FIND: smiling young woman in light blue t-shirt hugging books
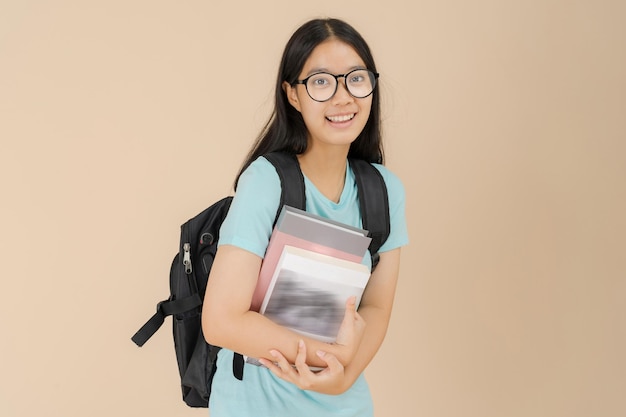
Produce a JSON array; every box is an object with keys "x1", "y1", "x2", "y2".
[{"x1": 203, "y1": 19, "x2": 408, "y2": 417}]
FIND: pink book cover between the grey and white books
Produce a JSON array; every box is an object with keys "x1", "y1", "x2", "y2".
[{"x1": 250, "y1": 228, "x2": 365, "y2": 311}]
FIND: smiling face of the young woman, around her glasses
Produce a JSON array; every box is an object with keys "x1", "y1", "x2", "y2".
[{"x1": 283, "y1": 39, "x2": 372, "y2": 152}]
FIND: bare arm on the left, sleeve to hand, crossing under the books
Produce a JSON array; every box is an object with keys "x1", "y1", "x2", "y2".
[{"x1": 202, "y1": 245, "x2": 364, "y2": 366}]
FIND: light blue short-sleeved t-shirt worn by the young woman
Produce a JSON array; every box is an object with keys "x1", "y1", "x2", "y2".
[{"x1": 209, "y1": 158, "x2": 408, "y2": 417}]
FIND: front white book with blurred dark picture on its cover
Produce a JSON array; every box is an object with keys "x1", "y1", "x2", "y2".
[{"x1": 259, "y1": 245, "x2": 370, "y2": 343}]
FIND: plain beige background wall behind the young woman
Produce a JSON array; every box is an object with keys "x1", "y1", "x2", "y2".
[{"x1": 0, "y1": 0, "x2": 626, "y2": 417}]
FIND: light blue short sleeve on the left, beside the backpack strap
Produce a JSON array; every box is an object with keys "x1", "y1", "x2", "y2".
[{"x1": 219, "y1": 157, "x2": 281, "y2": 258}]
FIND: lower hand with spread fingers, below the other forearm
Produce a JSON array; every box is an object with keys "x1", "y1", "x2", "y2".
[{"x1": 259, "y1": 340, "x2": 352, "y2": 395}]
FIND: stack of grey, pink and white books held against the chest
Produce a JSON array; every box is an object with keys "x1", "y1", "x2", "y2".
[{"x1": 251, "y1": 206, "x2": 371, "y2": 342}]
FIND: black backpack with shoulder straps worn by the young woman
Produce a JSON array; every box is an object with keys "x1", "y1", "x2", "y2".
[{"x1": 131, "y1": 152, "x2": 390, "y2": 407}]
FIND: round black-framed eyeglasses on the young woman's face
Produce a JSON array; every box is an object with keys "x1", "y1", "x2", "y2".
[{"x1": 295, "y1": 69, "x2": 379, "y2": 102}]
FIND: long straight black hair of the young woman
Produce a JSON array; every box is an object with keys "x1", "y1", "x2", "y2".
[{"x1": 235, "y1": 19, "x2": 384, "y2": 188}]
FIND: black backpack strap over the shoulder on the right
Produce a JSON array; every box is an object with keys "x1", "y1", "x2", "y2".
[{"x1": 350, "y1": 159, "x2": 391, "y2": 271}]
